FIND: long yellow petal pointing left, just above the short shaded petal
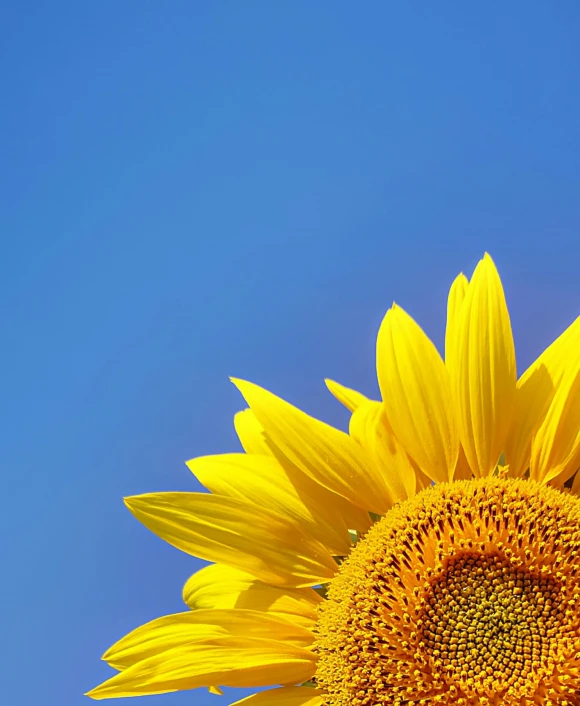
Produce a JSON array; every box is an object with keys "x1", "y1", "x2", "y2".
[{"x1": 125, "y1": 493, "x2": 336, "y2": 587}]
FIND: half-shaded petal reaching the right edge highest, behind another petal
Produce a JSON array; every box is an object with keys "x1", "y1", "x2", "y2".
[{"x1": 505, "y1": 317, "x2": 580, "y2": 477}]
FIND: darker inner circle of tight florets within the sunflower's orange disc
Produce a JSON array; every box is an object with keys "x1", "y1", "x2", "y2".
[{"x1": 418, "y1": 553, "x2": 565, "y2": 691}]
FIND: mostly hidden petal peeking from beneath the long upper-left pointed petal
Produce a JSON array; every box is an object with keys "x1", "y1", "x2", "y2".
[{"x1": 234, "y1": 409, "x2": 372, "y2": 532}]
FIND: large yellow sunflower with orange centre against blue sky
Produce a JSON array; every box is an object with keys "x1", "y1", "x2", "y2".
[{"x1": 89, "y1": 255, "x2": 580, "y2": 706}]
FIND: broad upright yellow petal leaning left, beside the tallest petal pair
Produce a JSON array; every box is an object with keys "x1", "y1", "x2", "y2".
[{"x1": 377, "y1": 305, "x2": 459, "y2": 481}]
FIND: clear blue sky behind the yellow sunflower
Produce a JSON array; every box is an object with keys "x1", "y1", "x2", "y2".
[{"x1": 0, "y1": 0, "x2": 580, "y2": 706}]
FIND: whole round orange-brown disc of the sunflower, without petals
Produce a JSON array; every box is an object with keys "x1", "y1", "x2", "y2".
[{"x1": 316, "y1": 478, "x2": 580, "y2": 706}]
